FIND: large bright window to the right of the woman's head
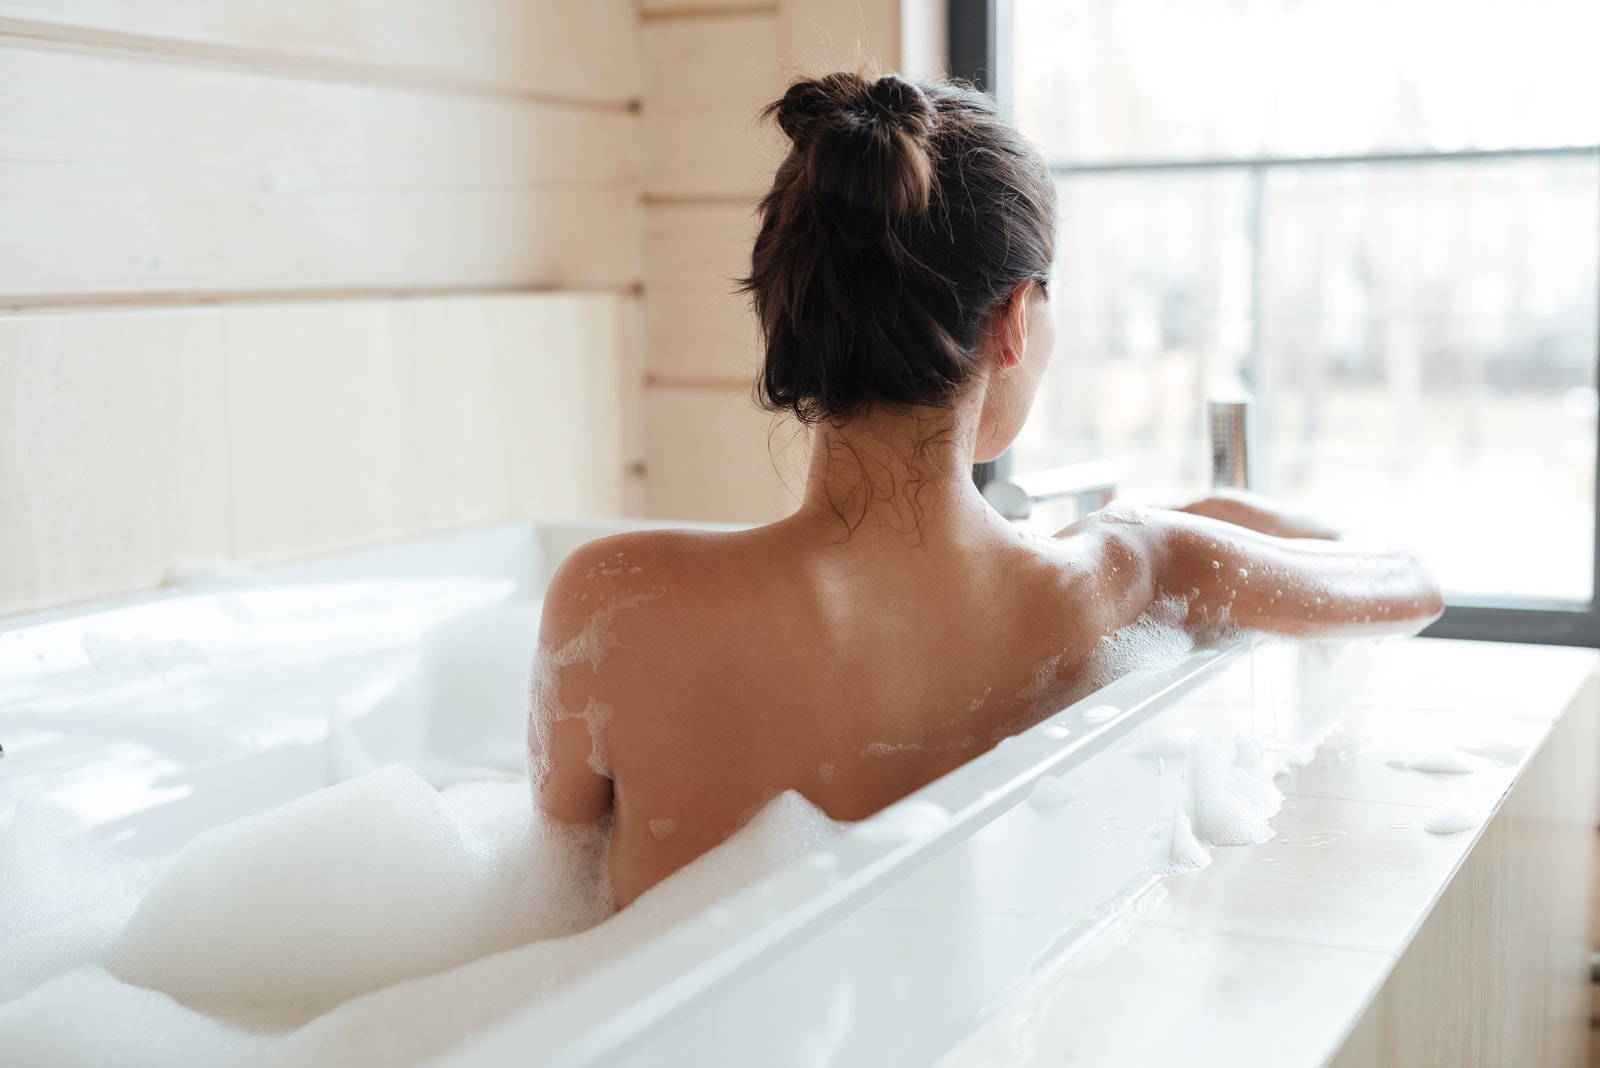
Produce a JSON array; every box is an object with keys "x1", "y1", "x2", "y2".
[{"x1": 972, "y1": 0, "x2": 1600, "y2": 644}]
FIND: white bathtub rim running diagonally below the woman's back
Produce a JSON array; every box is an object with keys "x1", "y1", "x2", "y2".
[{"x1": 427, "y1": 640, "x2": 1273, "y2": 1068}]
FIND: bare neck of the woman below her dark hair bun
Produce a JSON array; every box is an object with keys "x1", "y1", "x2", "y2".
[{"x1": 795, "y1": 409, "x2": 989, "y2": 545}]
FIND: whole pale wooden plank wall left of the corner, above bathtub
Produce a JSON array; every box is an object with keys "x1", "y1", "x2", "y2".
[{"x1": 0, "y1": 0, "x2": 645, "y2": 614}]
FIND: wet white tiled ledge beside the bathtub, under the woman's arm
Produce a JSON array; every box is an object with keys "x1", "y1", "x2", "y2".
[{"x1": 949, "y1": 640, "x2": 1597, "y2": 1066}]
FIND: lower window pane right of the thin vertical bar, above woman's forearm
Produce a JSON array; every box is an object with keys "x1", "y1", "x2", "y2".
[{"x1": 1245, "y1": 158, "x2": 1600, "y2": 601}]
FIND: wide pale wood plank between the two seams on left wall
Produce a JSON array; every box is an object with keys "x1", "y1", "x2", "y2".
[{"x1": 0, "y1": 41, "x2": 642, "y2": 305}]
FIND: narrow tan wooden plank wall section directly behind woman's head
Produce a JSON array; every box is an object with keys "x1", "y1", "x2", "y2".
[{"x1": 640, "y1": 0, "x2": 901, "y2": 521}]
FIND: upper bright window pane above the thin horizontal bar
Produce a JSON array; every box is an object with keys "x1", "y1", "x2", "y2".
[{"x1": 1013, "y1": 0, "x2": 1600, "y2": 163}]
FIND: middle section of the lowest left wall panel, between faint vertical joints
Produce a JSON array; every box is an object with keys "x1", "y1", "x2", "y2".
[{"x1": 221, "y1": 302, "x2": 451, "y2": 561}]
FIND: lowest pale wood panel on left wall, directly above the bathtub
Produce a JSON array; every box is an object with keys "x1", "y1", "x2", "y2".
[{"x1": 0, "y1": 294, "x2": 635, "y2": 614}]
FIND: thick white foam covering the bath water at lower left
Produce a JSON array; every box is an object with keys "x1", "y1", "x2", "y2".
[{"x1": 0, "y1": 767, "x2": 844, "y2": 1068}]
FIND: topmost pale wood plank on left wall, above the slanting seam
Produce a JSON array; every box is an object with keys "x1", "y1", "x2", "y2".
[{"x1": 0, "y1": 0, "x2": 638, "y2": 106}]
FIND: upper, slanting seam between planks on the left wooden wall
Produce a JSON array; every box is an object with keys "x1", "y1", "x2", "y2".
[{"x1": 0, "y1": 18, "x2": 642, "y2": 112}]
